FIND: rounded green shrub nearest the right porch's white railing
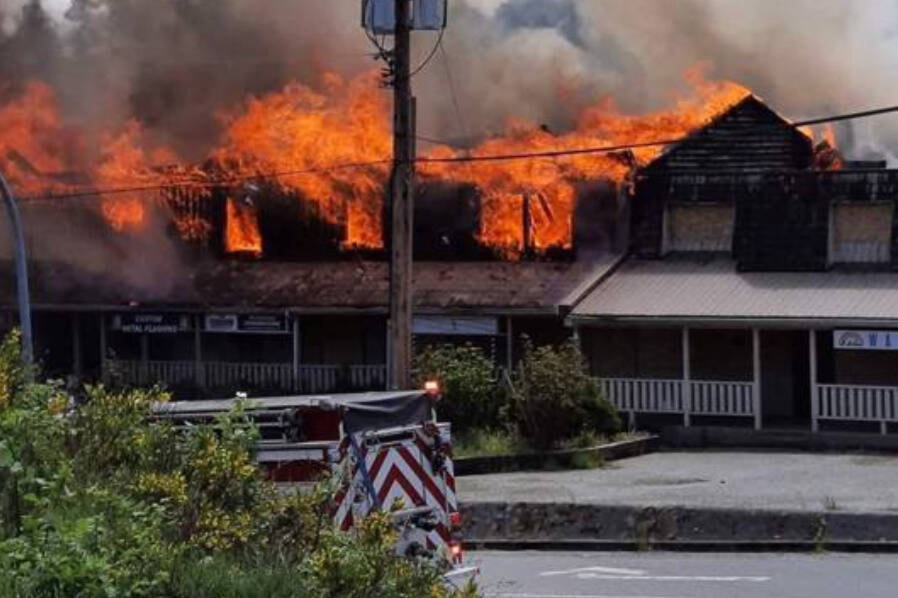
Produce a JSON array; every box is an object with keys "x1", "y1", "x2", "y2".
[{"x1": 510, "y1": 342, "x2": 620, "y2": 450}]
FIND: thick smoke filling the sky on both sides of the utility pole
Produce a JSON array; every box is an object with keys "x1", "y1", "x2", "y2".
[{"x1": 0, "y1": 0, "x2": 898, "y2": 296}]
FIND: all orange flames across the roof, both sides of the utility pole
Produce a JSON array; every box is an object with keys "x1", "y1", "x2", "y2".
[{"x1": 0, "y1": 69, "x2": 768, "y2": 257}]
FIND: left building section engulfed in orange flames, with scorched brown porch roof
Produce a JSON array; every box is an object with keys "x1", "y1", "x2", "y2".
[{"x1": 0, "y1": 61, "x2": 764, "y2": 395}]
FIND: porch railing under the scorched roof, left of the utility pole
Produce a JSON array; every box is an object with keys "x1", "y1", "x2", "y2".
[{"x1": 104, "y1": 359, "x2": 387, "y2": 393}]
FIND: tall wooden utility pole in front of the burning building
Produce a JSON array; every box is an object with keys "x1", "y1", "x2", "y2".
[{"x1": 387, "y1": 0, "x2": 415, "y2": 389}]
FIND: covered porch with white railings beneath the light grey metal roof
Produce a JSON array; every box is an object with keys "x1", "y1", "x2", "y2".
[{"x1": 581, "y1": 327, "x2": 898, "y2": 434}]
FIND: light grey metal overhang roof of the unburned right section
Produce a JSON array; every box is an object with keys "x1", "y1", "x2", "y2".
[{"x1": 570, "y1": 255, "x2": 898, "y2": 324}]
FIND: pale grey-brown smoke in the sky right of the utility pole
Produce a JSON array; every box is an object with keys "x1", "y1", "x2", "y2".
[{"x1": 416, "y1": 0, "x2": 898, "y2": 159}]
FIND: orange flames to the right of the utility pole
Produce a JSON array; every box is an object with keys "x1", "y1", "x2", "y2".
[{"x1": 422, "y1": 70, "x2": 750, "y2": 257}]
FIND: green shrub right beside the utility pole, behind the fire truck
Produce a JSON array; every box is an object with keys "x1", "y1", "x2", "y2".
[{"x1": 415, "y1": 345, "x2": 502, "y2": 431}]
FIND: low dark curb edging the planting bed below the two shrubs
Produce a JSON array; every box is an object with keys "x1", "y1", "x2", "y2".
[{"x1": 453, "y1": 436, "x2": 661, "y2": 477}]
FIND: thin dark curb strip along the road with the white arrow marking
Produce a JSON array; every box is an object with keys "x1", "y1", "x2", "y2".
[{"x1": 465, "y1": 540, "x2": 898, "y2": 554}]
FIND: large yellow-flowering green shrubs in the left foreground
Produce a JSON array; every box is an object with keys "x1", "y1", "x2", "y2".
[{"x1": 0, "y1": 332, "x2": 473, "y2": 598}]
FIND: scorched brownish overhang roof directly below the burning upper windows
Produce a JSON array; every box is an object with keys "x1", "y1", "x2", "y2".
[{"x1": 0, "y1": 256, "x2": 617, "y2": 313}]
